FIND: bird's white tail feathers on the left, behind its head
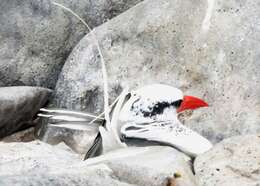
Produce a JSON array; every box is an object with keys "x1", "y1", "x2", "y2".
[{"x1": 38, "y1": 89, "x2": 129, "y2": 159}]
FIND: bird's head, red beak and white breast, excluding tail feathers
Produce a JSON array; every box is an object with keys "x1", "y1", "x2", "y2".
[{"x1": 118, "y1": 84, "x2": 212, "y2": 157}]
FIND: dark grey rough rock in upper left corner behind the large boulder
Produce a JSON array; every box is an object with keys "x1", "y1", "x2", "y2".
[{"x1": 0, "y1": 0, "x2": 141, "y2": 88}]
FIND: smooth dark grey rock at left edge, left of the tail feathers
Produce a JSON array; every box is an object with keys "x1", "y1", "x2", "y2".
[{"x1": 0, "y1": 86, "x2": 52, "y2": 138}]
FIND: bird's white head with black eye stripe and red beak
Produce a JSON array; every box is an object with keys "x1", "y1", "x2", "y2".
[{"x1": 120, "y1": 84, "x2": 208, "y2": 122}]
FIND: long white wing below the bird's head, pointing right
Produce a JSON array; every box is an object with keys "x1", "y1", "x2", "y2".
[{"x1": 121, "y1": 121, "x2": 212, "y2": 157}]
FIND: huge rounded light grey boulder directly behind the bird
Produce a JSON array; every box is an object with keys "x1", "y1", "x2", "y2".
[{"x1": 52, "y1": 0, "x2": 260, "y2": 142}]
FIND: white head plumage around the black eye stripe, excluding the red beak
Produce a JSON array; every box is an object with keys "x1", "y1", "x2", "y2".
[{"x1": 119, "y1": 84, "x2": 183, "y2": 123}]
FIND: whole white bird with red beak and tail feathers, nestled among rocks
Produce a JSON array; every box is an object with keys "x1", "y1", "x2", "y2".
[{"x1": 38, "y1": 84, "x2": 212, "y2": 159}]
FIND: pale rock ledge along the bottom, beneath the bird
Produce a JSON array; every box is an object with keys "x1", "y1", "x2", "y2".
[{"x1": 0, "y1": 141, "x2": 195, "y2": 186}]
